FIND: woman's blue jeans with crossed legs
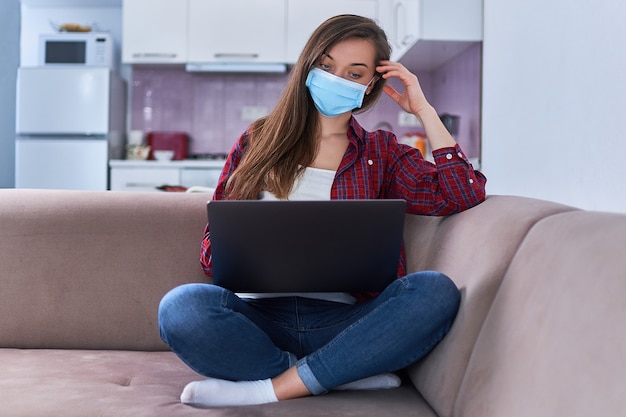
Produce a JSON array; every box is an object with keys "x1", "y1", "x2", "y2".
[{"x1": 159, "y1": 271, "x2": 460, "y2": 395}]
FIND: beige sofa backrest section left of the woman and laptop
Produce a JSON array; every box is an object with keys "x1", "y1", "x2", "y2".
[{"x1": 0, "y1": 189, "x2": 210, "y2": 350}]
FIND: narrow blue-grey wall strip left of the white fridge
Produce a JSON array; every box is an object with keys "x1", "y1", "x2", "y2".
[{"x1": 0, "y1": 0, "x2": 20, "y2": 188}]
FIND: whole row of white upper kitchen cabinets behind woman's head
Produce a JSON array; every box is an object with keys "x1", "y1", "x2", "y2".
[{"x1": 122, "y1": 0, "x2": 483, "y2": 71}]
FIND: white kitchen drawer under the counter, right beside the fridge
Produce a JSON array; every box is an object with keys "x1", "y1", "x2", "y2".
[{"x1": 111, "y1": 167, "x2": 181, "y2": 191}]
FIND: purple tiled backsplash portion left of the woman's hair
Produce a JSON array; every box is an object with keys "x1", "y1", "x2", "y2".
[{"x1": 130, "y1": 66, "x2": 287, "y2": 154}]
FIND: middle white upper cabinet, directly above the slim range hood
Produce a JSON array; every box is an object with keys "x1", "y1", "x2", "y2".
[{"x1": 188, "y1": 0, "x2": 286, "y2": 64}]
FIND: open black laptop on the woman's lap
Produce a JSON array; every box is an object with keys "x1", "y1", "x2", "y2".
[{"x1": 207, "y1": 200, "x2": 406, "y2": 293}]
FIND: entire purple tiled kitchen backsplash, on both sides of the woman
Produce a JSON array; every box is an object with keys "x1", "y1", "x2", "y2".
[{"x1": 131, "y1": 45, "x2": 481, "y2": 158}]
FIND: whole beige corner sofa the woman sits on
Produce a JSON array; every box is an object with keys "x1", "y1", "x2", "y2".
[{"x1": 0, "y1": 189, "x2": 626, "y2": 417}]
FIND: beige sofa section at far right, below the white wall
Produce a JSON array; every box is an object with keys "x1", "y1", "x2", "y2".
[{"x1": 455, "y1": 211, "x2": 626, "y2": 417}]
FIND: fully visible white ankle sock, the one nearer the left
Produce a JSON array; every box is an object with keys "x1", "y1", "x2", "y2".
[{"x1": 180, "y1": 378, "x2": 278, "y2": 407}]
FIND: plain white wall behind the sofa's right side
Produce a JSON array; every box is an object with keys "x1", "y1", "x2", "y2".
[{"x1": 482, "y1": 0, "x2": 626, "y2": 212}]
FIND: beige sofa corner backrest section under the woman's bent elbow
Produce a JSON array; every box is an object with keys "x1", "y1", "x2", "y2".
[{"x1": 405, "y1": 196, "x2": 575, "y2": 416}]
